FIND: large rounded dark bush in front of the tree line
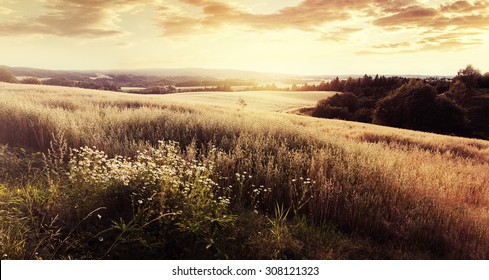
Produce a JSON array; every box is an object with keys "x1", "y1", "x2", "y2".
[{"x1": 373, "y1": 80, "x2": 469, "y2": 135}]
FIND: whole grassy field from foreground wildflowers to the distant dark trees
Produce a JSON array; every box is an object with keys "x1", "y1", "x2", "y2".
[{"x1": 0, "y1": 83, "x2": 489, "y2": 259}]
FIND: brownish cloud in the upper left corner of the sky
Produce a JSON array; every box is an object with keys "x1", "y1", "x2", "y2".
[{"x1": 0, "y1": 0, "x2": 148, "y2": 38}]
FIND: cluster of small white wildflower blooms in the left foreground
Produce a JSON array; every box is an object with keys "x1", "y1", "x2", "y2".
[{"x1": 69, "y1": 141, "x2": 234, "y2": 242}]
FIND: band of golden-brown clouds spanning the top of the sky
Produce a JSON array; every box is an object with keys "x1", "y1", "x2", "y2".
[{"x1": 0, "y1": 0, "x2": 489, "y2": 55}]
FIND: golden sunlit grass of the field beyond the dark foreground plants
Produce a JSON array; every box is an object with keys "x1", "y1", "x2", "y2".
[{"x1": 0, "y1": 83, "x2": 489, "y2": 258}]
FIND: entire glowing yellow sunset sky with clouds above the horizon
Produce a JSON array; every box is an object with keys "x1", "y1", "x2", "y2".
[{"x1": 0, "y1": 0, "x2": 489, "y2": 75}]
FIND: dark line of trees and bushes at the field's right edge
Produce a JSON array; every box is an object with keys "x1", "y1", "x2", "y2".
[{"x1": 310, "y1": 65, "x2": 489, "y2": 138}]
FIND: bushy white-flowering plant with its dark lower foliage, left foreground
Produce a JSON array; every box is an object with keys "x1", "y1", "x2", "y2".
[{"x1": 44, "y1": 141, "x2": 235, "y2": 259}]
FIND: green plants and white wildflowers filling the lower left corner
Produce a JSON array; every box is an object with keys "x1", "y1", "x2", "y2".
[{"x1": 0, "y1": 138, "x2": 235, "y2": 259}]
